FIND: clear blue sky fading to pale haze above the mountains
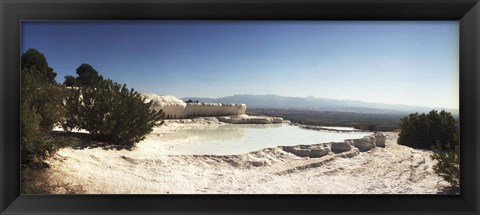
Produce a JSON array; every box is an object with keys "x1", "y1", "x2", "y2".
[{"x1": 21, "y1": 21, "x2": 459, "y2": 109}]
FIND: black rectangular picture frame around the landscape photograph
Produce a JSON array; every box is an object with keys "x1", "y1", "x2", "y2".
[{"x1": 0, "y1": 0, "x2": 480, "y2": 214}]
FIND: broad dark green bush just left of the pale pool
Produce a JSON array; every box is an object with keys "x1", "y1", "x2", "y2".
[{"x1": 63, "y1": 80, "x2": 164, "y2": 147}]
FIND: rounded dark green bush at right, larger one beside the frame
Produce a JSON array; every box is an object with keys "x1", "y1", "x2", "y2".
[{"x1": 397, "y1": 110, "x2": 458, "y2": 150}]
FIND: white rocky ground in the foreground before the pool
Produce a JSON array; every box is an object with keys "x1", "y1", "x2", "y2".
[{"x1": 43, "y1": 120, "x2": 448, "y2": 194}]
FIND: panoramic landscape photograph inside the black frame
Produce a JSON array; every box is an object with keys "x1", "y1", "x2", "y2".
[{"x1": 19, "y1": 20, "x2": 463, "y2": 196}]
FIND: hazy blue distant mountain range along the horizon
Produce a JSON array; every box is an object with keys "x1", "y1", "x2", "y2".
[{"x1": 182, "y1": 95, "x2": 458, "y2": 115}]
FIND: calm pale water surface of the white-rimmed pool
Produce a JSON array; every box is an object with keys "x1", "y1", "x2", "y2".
[{"x1": 153, "y1": 124, "x2": 371, "y2": 155}]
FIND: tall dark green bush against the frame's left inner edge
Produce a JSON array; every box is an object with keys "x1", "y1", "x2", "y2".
[{"x1": 20, "y1": 49, "x2": 63, "y2": 165}]
